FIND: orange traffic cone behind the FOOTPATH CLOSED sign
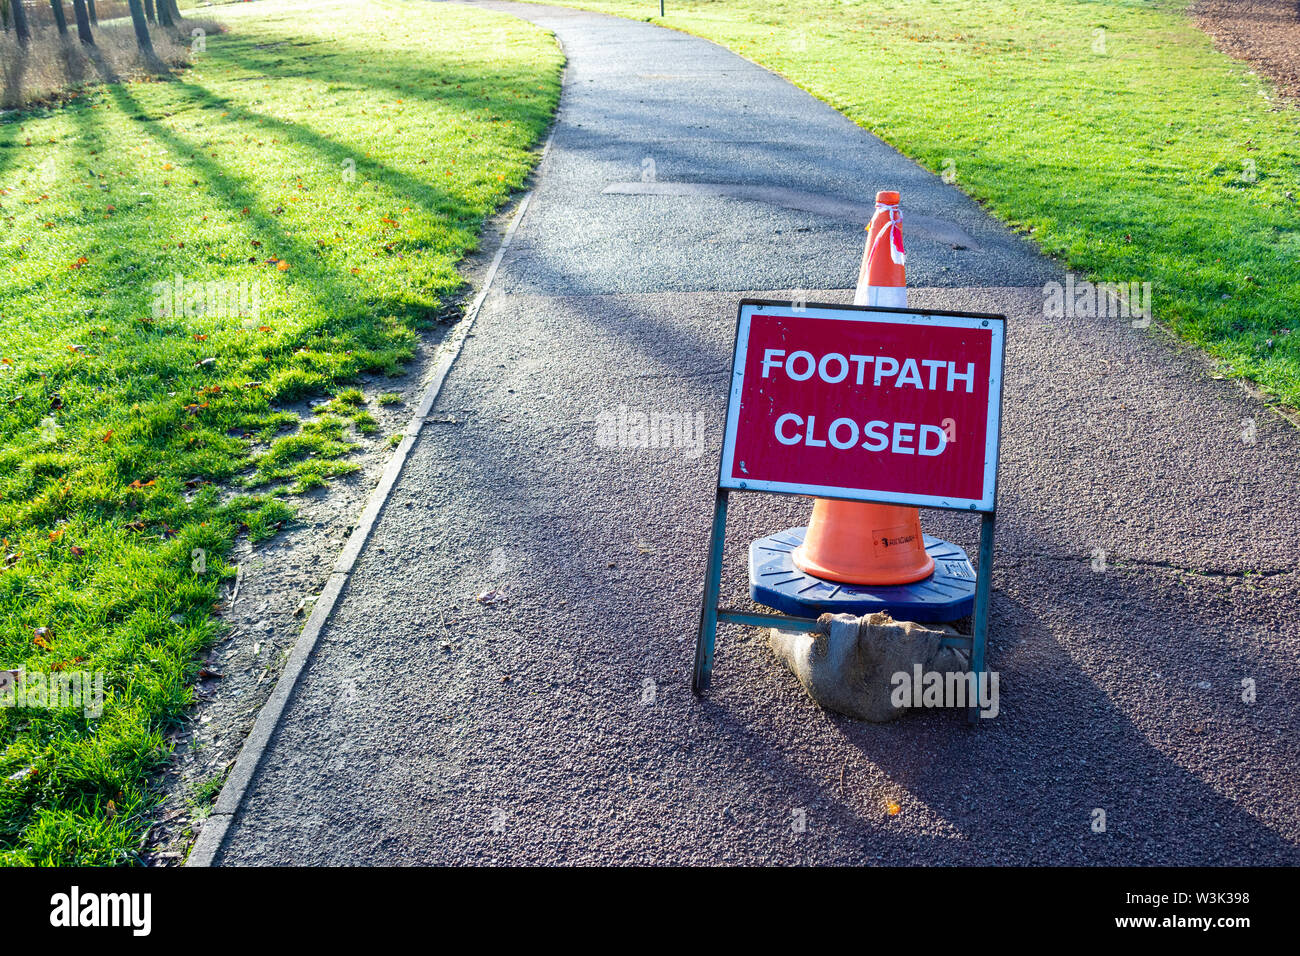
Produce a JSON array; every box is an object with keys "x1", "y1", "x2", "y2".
[{"x1": 792, "y1": 190, "x2": 935, "y2": 587}]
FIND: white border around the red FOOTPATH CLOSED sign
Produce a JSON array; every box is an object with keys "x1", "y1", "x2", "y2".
[{"x1": 718, "y1": 302, "x2": 1006, "y2": 511}]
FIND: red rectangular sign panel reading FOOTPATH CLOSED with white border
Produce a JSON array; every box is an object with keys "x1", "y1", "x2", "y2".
[{"x1": 719, "y1": 299, "x2": 1004, "y2": 511}]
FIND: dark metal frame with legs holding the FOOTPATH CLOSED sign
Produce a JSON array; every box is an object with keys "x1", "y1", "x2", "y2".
[{"x1": 690, "y1": 299, "x2": 1006, "y2": 723}]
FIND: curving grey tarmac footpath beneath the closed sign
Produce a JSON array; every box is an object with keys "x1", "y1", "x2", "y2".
[{"x1": 208, "y1": 3, "x2": 1300, "y2": 865}]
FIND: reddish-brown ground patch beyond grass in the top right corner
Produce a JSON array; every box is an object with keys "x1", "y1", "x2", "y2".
[{"x1": 1192, "y1": 0, "x2": 1300, "y2": 100}]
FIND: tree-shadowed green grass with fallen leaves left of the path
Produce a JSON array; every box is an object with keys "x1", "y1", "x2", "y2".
[{"x1": 0, "y1": 0, "x2": 562, "y2": 864}]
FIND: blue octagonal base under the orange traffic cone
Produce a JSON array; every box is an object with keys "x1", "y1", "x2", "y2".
[{"x1": 749, "y1": 528, "x2": 975, "y2": 623}]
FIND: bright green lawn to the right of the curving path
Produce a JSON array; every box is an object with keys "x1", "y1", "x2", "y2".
[{"x1": 538, "y1": 0, "x2": 1300, "y2": 406}]
